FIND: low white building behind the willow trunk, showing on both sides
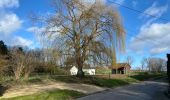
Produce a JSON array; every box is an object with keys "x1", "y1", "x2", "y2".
[{"x1": 70, "y1": 66, "x2": 95, "y2": 75}]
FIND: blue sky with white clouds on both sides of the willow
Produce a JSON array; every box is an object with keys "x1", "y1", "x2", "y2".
[{"x1": 0, "y1": 0, "x2": 170, "y2": 68}]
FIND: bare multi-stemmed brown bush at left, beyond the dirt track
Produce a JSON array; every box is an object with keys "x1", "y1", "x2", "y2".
[{"x1": 10, "y1": 48, "x2": 38, "y2": 80}]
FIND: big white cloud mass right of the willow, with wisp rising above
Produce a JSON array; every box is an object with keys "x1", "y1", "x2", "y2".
[{"x1": 129, "y1": 2, "x2": 170, "y2": 55}]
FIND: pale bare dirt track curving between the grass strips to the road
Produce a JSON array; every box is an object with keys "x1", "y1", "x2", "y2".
[{"x1": 0, "y1": 82, "x2": 105, "y2": 98}]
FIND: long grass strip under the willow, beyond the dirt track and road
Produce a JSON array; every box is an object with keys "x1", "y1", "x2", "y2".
[{"x1": 0, "y1": 73, "x2": 165, "y2": 87}]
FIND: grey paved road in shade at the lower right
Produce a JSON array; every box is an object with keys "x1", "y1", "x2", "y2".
[{"x1": 78, "y1": 80, "x2": 170, "y2": 100}]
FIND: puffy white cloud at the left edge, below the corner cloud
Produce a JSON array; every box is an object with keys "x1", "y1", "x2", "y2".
[{"x1": 0, "y1": 13, "x2": 22, "y2": 35}]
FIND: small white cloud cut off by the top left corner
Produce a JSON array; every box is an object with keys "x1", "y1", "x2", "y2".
[{"x1": 0, "y1": 0, "x2": 19, "y2": 8}]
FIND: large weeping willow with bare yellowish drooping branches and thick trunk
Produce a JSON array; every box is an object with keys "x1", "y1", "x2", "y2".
[{"x1": 33, "y1": 0, "x2": 125, "y2": 77}]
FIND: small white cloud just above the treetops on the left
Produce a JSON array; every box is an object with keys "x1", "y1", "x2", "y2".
[{"x1": 13, "y1": 36, "x2": 33, "y2": 47}]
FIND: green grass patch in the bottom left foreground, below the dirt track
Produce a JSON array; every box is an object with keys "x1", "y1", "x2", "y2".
[{"x1": 1, "y1": 90, "x2": 84, "y2": 100}]
